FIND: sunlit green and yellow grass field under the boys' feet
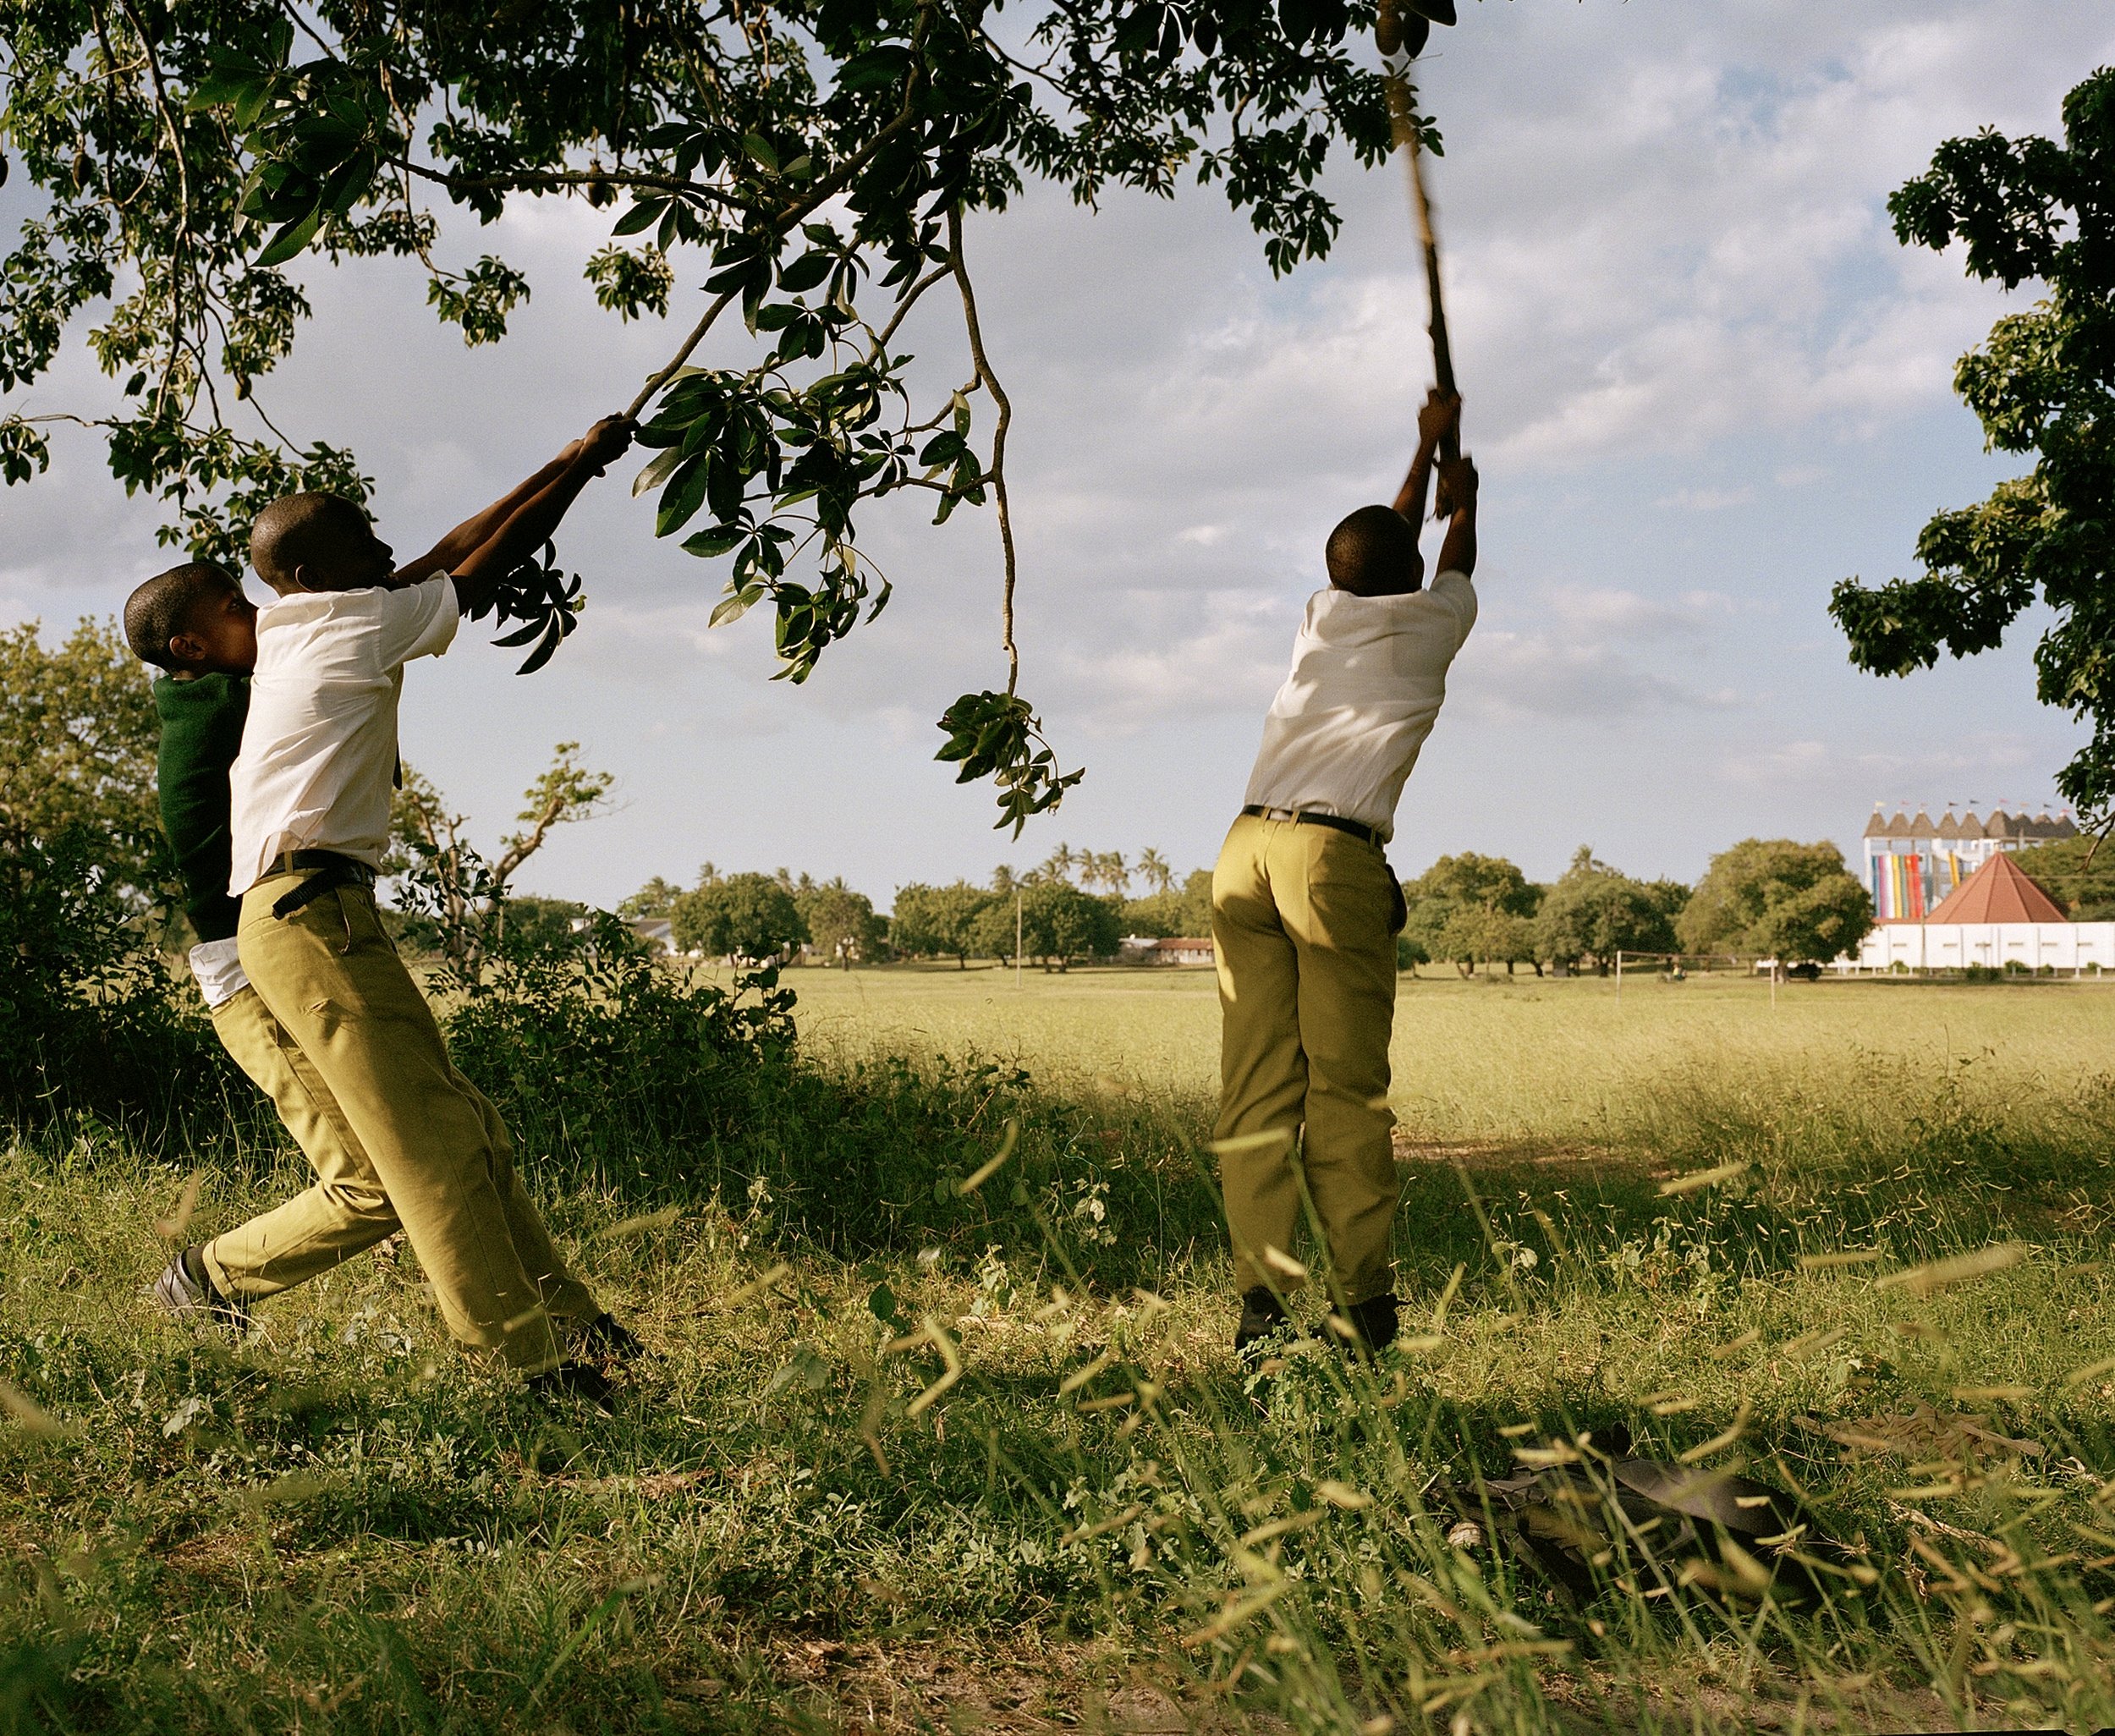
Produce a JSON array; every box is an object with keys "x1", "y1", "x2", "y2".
[{"x1": 0, "y1": 969, "x2": 2115, "y2": 1736}]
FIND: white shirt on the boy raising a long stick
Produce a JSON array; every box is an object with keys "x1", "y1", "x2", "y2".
[{"x1": 1244, "y1": 571, "x2": 1476, "y2": 838}]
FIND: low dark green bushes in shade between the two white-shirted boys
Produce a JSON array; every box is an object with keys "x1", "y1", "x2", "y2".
[{"x1": 447, "y1": 915, "x2": 1218, "y2": 1283}]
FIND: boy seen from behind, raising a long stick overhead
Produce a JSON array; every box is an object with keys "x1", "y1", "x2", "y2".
[{"x1": 1212, "y1": 391, "x2": 1476, "y2": 1354}]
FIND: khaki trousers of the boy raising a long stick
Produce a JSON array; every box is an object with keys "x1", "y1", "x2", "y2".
[{"x1": 1212, "y1": 814, "x2": 1398, "y2": 1305}]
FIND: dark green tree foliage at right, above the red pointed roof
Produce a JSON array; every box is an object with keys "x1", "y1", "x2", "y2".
[{"x1": 1830, "y1": 68, "x2": 2115, "y2": 818}]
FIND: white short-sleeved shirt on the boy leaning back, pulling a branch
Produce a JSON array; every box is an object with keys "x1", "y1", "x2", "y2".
[{"x1": 228, "y1": 575, "x2": 461, "y2": 898}]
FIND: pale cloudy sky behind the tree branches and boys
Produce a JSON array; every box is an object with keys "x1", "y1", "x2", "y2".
[{"x1": 0, "y1": 0, "x2": 2115, "y2": 907}]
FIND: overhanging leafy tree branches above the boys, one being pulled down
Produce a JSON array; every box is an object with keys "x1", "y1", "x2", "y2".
[{"x1": 0, "y1": 0, "x2": 1421, "y2": 829}]
